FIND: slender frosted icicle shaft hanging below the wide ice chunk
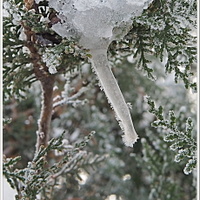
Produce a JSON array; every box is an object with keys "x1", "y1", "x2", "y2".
[{"x1": 91, "y1": 49, "x2": 138, "y2": 147}]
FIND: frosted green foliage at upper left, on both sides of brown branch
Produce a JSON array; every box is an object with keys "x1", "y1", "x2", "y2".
[{"x1": 3, "y1": 0, "x2": 87, "y2": 100}]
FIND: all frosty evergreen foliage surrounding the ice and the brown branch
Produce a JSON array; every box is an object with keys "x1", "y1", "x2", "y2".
[{"x1": 3, "y1": 0, "x2": 197, "y2": 200}]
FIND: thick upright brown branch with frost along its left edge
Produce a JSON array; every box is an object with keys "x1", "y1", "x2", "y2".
[{"x1": 22, "y1": 23, "x2": 55, "y2": 151}]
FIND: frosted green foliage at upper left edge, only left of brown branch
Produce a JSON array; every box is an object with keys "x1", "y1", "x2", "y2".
[{"x1": 3, "y1": 1, "x2": 34, "y2": 98}]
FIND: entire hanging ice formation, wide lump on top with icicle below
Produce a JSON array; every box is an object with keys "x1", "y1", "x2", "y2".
[{"x1": 49, "y1": 0, "x2": 153, "y2": 147}]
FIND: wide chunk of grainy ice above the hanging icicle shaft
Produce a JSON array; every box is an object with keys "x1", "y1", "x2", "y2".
[{"x1": 49, "y1": 0, "x2": 152, "y2": 49}]
